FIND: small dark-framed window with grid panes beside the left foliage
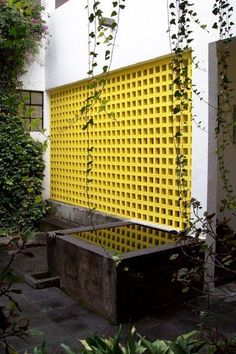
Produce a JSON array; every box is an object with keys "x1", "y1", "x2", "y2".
[{"x1": 21, "y1": 90, "x2": 43, "y2": 131}]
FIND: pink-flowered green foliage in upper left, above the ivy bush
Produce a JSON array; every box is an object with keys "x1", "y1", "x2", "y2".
[{"x1": 0, "y1": 0, "x2": 47, "y2": 112}]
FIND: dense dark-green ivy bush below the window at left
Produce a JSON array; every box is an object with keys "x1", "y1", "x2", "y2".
[{"x1": 0, "y1": 113, "x2": 45, "y2": 233}]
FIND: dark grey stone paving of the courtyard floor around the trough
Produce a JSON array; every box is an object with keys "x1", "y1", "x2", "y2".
[{"x1": 0, "y1": 239, "x2": 236, "y2": 354}]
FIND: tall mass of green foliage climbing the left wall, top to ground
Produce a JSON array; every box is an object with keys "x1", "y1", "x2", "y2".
[{"x1": 0, "y1": 0, "x2": 47, "y2": 235}]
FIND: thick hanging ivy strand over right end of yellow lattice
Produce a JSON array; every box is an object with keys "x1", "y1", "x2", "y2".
[{"x1": 168, "y1": 0, "x2": 195, "y2": 227}]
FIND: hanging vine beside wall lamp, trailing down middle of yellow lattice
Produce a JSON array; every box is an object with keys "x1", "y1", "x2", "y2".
[{"x1": 80, "y1": 0, "x2": 125, "y2": 232}]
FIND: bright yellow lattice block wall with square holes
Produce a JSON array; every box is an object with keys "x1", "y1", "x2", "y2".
[{"x1": 50, "y1": 57, "x2": 192, "y2": 228}]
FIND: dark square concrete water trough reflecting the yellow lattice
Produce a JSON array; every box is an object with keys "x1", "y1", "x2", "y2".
[{"x1": 47, "y1": 221, "x2": 204, "y2": 324}]
